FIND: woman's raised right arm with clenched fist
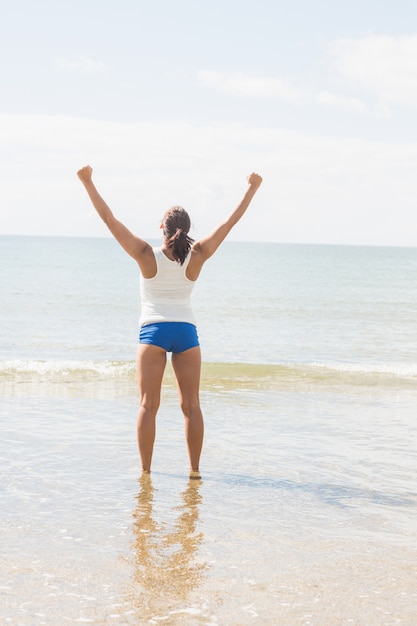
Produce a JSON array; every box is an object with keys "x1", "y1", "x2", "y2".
[{"x1": 193, "y1": 172, "x2": 262, "y2": 262}]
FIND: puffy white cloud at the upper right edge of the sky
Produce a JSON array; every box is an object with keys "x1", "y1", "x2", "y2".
[{"x1": 328, "y1": 34, "x2": 417, "y2": 108}]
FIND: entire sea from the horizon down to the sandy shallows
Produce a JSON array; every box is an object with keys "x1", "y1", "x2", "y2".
[{"x1": 0, "y1": 236, "x2": 417, "y2": 626}]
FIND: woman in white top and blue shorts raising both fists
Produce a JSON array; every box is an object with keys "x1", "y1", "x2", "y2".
[{"x1": 78, "y1": 165, "x2": 262, "y2": 478}]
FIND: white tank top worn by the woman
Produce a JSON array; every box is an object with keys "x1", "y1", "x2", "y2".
[{"x1": 139, "y1": 248, "x2": 196, "y2": 326}]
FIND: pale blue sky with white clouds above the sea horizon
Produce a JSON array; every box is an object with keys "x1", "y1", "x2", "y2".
[{"x1": 0, "y1": 0, "x2": 417, "y2": 246}]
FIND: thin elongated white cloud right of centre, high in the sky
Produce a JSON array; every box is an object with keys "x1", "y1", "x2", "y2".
[{"x1": 199, "y1": 70, "x2": 301, "y2": 101}]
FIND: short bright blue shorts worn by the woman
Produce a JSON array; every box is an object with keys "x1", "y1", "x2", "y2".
[{"x1": 139, "y1": 322, "x2": 200, "y2": 354}]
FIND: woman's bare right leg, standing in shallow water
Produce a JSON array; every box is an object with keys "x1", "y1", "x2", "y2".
[{"x1": 172, "y1": 346, "x2": 204, "y2": 472}]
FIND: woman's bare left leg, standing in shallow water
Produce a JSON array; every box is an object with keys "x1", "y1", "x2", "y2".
[{"x1": 136, "y1": 343, "x2": 167, "y2": 472}]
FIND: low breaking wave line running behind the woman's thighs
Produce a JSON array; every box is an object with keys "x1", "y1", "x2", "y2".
[{"x1": 0, "y1": 360, "x2": 417, "y2": 390}]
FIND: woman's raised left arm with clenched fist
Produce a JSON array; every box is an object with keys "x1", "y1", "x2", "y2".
[{"x1": 77, "y1": 165, "x2": 151, "y2": 267}]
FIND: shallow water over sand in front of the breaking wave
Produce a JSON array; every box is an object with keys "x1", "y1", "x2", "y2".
[{"x1": 0, "y1": 376, "x2": 417, "y2": 626}]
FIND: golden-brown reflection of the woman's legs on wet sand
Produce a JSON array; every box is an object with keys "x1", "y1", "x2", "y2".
[{"x1": 127, "y1": 474, "x2": 206, "y2": 619}]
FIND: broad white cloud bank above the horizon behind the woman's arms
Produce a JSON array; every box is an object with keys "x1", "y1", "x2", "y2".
[{"x1": 0, "y1": 115, "x2": 417, "y2": 246}]
